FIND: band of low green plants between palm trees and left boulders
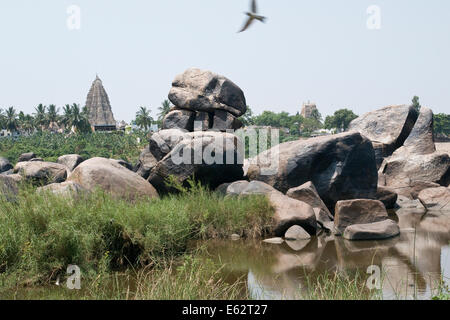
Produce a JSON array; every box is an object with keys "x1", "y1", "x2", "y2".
[{"x1": 0, "y1": 131, "x2": 147, "y2": 163}]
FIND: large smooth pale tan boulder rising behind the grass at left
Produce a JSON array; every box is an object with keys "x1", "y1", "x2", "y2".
[{"x1": 67, "y1": 158, "x2": 158, "y2": 200}]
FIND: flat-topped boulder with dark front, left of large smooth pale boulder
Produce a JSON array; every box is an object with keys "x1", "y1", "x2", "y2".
[{"x1": 14, "y1": 161, "x2": 67, "y2": 185}]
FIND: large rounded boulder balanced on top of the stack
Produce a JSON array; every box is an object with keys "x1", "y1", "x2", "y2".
[{"x1": 169, "y1": 68, "x2": 247, "y2": 117}]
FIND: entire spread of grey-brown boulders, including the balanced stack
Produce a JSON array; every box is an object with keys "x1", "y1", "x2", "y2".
[{"x1": 0, "y1": 69, "x2": 450, "y2": 247}]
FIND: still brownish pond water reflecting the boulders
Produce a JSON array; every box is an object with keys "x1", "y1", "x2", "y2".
[{"x1": 200, "y1": 210, "x2": 450, "y2": 299}]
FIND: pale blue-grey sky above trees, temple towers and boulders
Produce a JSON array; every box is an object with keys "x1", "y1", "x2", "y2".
[{"x1": 0, "y1": 0, "x2": 450, "y2": 121}]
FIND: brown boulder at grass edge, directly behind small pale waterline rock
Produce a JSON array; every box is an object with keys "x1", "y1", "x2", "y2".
[{"x1": 268, "y1": 192, "x2": 317, "y2": 237}]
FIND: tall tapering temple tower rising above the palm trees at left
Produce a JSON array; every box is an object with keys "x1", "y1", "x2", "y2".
[{"x1": 86, "y1": 75, "x2": 116, "y2": 131}]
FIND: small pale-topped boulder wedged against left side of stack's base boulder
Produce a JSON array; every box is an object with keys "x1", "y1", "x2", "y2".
[{"x1": 149, "y1": 129, "x2": 188, "y2": 161}]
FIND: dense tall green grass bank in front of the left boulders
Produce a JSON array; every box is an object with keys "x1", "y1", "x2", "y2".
[{"x1": 0, "y1": 181, "x2": 273, "y2": 287}]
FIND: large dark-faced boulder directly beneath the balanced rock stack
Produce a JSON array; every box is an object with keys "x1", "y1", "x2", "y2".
[{"x1": 149, "y1": 131, "x2": 243, "y2": 192}]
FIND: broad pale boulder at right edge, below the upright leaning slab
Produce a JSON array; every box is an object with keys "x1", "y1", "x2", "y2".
[{"x1": 379, "y1": 152, "x2": 450, "y2": 199}]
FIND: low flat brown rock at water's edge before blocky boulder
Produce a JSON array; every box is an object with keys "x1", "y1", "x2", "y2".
[{"x1": 343, "y1": 219, "x2": 400, "y2": 240}]
